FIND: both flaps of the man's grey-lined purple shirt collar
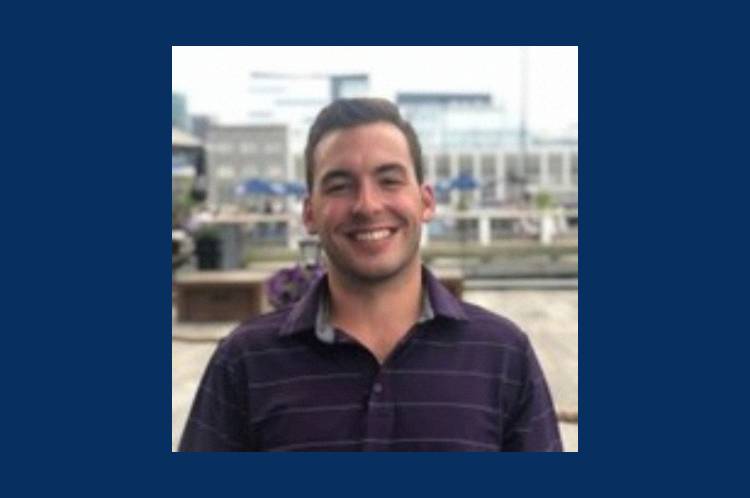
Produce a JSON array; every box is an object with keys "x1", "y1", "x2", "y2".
[{"x1": 279, "y1": 267, "x2": 467, "y2": 342}]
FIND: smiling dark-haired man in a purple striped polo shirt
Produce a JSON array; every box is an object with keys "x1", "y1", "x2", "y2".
[{"x1": 180, "y1": 99, "x2": 561, "y2": 451}]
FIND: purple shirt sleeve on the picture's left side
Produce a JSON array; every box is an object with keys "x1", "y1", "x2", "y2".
[{"x1": 178, "y1": 339, "x2": 253, "y2": 451}]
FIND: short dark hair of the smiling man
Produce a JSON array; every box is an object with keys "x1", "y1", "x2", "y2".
[{"x1": 305, "y1": 98, "x2": 424, "y2": 193}]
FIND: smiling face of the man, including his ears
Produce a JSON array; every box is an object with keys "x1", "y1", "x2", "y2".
[{"x1": 304, "y1": 122, "x2": 435, "y2": 282}]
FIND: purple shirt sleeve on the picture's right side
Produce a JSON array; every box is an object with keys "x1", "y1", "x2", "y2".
[{"x1": 503, "y1": 338, "x2": 563, "y2": 451}]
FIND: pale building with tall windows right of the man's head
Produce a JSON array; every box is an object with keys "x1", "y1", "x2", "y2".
[{"x1": 396, "y1": 93, "x2": 578, "y2": 207}]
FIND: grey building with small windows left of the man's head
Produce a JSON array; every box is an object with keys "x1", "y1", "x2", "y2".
[{"x1": 206, "y1": 125, "x2": 293, "y2": 205}]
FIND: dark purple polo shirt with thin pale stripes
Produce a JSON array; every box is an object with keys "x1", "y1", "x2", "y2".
[{"x1": 179, "y1": 269, "x2": 562, "y2": 451}]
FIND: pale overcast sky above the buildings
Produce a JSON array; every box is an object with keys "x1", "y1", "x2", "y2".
[{"x1": 172, "y1": 46, "x2": 578, "y2": 134}]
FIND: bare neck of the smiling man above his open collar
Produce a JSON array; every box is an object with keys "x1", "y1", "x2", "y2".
[{"x1": 328, "y1": 261, "x2": 422, "y2": 363}]
